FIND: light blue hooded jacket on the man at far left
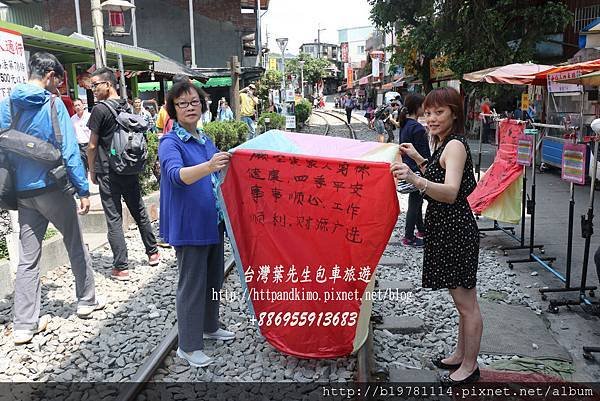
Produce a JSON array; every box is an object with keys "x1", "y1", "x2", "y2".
[{"x1": 0, "y1": 83, "x2": 90, "y2": 196}]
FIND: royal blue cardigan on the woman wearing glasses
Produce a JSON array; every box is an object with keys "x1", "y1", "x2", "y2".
[{"x1": 158, "y1": 123, "x2": 221, "y2": 246}]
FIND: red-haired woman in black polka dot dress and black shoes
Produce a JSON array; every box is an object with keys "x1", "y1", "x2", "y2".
[{"x1": 391, "y1": 88, "x2": 483, "y2": 385}]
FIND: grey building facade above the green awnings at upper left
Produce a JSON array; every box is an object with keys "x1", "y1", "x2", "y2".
[{"x1": 0, "y1": 0, "x2": 269, "y2": 67}]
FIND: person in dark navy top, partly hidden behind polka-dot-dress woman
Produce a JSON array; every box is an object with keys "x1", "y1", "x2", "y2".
[{"x1": 398, "y1": 93, "x2": 431, "y2": 247}]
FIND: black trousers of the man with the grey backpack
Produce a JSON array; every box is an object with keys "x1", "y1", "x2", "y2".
[{"x1": 96, "y1": 173, "x2": 158, "y2": 270}]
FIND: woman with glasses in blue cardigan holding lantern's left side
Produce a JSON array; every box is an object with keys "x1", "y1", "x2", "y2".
[{"x1": 158, "y1": 82, "x2": 235, "y2": 367}]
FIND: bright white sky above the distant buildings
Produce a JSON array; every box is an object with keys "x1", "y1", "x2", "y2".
[{"x1": 261, "y1": 0, "x2": 372, "y2": 54}]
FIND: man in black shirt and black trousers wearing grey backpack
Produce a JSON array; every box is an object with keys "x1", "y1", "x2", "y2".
[{"x1": 88, "y1": 67, "x2": 160, "y2": 280}]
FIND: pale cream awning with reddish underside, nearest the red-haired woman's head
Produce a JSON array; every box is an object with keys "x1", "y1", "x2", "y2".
[{"x1": 463, "y1": 63, "x2": 554, "y2": 85}]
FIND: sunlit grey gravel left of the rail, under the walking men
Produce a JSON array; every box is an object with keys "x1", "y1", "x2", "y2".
[{"x1": 0, "y1": 223, "x2": 223, "y2": 382}]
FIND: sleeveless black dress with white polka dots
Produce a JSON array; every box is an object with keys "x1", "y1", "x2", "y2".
[{"x1": 422, "y1": 135, "x2": 479, "y2": 290}]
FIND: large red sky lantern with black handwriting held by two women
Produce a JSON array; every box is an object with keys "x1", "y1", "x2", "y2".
[{"x1": 220, "y1": 130, "x2": 399, "y2": 358}]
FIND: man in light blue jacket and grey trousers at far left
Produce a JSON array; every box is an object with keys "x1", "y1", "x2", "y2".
[{"x1": 0, "y1": 52, "x2": 104, "y2": 344}]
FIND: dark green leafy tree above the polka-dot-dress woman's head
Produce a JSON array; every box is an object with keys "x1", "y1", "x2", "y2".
[{"x1": 369, "y1": 0, "x2": 572, "y2": 91}]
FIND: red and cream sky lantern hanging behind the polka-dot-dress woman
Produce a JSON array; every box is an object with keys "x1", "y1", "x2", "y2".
[{"x1": 468, "y1": 120, "x2": 524, "y2": 224}]
